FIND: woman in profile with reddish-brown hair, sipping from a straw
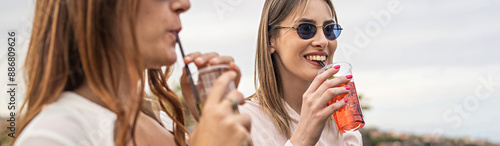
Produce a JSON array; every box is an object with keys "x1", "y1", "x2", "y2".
[{"x1": 14, "y1": 0, "x2": 250, "y2": 146}]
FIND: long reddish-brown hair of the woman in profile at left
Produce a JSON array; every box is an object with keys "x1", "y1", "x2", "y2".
[{"x1": 17, "y1": 0, "x2": 187, "y2": 146}]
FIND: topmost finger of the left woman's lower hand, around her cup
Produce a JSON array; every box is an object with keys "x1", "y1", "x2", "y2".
[{"x1": 205, "y1": 71, "x2": 236, "y2": 106}]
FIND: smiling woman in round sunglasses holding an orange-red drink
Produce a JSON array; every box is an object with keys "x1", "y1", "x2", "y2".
[{"x1": 239, "y1": 0, "x2": 362, "y2": 146}]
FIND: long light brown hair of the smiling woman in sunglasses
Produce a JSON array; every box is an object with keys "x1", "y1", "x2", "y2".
[{"x1": 248, "y1": 0, "x2": 338, "y2": 138}]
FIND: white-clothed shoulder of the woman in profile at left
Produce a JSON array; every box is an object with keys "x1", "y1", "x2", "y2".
[{"x1": 15, "y1": 92, "x2": 116, "y2": 145}]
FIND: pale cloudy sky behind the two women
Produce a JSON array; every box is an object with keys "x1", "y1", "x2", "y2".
[{"x1": 0, "y1": 0, "x2": 500, "y2": 143}]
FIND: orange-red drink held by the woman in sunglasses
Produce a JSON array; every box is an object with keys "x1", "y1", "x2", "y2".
[{"x1": 328, "y1": 82, "x2": 365, "y2": 133}]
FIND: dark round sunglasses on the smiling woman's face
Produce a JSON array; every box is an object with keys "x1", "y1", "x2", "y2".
[{"x1": 275, "y1": 23, "x2": 342, "y2": 40}]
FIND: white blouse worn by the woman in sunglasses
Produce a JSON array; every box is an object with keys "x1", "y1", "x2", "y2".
[{"x1": 239, "y1": 99, "x2": 363, "y2": 146}]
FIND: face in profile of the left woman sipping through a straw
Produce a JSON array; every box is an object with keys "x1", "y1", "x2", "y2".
[{"x1": 136, "y1": 0, "x2": 190, "y2": 68}]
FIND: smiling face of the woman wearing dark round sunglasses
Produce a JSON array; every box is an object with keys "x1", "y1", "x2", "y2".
[{"x1": 271, "y1": 0, "x2": 337, "y2": 81}]
